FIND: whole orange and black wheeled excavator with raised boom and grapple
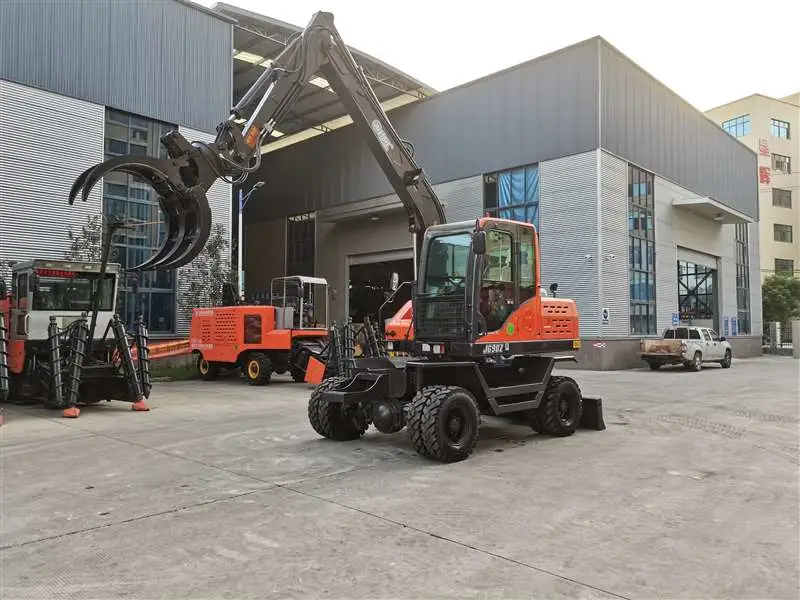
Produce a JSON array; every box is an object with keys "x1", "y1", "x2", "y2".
[{"x1": 70, "y1": 12, "x2": 605, "y2": 462}]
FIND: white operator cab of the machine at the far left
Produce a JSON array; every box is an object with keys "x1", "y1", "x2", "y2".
[{"x1": 9, "y1": 260, "x2": 120, "y2": 340}]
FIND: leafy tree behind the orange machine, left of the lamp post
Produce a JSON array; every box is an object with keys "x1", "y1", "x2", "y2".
[{"x1": 178, "y1": 223, "x2": 237, "y2": 313}]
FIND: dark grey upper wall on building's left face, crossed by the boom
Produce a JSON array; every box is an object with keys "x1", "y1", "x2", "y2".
[{"x1": 249, "y1": 40, "x2": 599, "y2": 219}]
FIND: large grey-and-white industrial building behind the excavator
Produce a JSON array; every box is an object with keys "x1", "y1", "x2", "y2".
[{"x1": 245, "y1": 38, "x2": 761, "y2": 369}]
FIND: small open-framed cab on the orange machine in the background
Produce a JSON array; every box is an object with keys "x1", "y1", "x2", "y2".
[{"x1": 270, "y1": 275, "x2": 330, "y2": 329}]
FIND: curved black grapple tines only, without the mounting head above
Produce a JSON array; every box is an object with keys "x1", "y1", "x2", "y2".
[{"x1": 69, "y1": 155, "x2": 211, "y2": 271}]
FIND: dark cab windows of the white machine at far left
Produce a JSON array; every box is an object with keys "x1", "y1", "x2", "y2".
[{"x1": 33, "y1": 271, "x2": 115, "y2": 311}]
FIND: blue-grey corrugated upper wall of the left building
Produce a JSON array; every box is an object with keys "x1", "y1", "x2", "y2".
[{"x1": 0, "y1": 0, "x2": 233, "y2": 131}]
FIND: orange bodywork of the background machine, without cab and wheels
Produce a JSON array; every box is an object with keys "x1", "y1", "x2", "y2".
[{"x1": 189, "y1": 305, "x2": 328, "y2": 363}]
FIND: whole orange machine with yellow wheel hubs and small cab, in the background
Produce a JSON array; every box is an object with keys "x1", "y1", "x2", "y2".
[{"x1": 190, "y1": 275, "x2": 328, "y2": 385}]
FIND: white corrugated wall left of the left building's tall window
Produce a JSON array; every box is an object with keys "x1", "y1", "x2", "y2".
[{"x1": 0, "y1": 79, "x2": 105, "y2": 283}]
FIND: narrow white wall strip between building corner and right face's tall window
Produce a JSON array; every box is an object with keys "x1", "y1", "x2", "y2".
[{"x1": 600, "y1": 151, "x2": 632, "y2": 337}]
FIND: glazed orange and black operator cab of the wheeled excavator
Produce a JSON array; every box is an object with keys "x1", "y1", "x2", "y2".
[{"x1": 413, "y1": 217, "x2": 577, "y2": 356}]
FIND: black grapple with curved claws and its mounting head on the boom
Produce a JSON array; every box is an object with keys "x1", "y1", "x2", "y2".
[{"x1": 69, "y1": 131, "x2": 223, "y2": 271}]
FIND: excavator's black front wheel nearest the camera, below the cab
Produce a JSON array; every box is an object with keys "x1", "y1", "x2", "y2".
[{"x1": 420, "y1": 385, "x2": 481, "y2": 463}]
